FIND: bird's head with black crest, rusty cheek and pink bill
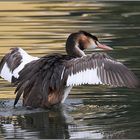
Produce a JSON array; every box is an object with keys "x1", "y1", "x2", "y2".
[{"x1": 66, "y1": 31, "x2": 113, "y2": 57}]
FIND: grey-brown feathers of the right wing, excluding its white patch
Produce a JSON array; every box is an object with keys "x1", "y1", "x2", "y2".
[{"x1": 63, "y1": 53, "x2": 139, "y2": 88}]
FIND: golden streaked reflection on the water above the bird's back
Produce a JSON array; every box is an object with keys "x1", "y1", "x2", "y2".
[{"x1": 0, "y1": 0, "x2": 109, "y2": 54}]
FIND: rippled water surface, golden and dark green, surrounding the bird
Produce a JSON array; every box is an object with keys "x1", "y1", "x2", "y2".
[{"x1": 0, "y1": 0, "x2": 140, "y2": 139}]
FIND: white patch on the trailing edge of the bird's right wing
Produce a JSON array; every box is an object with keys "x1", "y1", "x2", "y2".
[{"x1": 66, "y1": 68, "x2": 102, "y2": 86}]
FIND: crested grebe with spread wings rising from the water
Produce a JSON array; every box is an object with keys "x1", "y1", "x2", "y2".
[{"x1": 0, "y1": 30, "x2": 139, "y2": 108}]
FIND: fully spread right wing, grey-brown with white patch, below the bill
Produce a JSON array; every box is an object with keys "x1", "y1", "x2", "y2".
[{"x1": 63, "y1": 53, "x2": 139, "y2": 88}]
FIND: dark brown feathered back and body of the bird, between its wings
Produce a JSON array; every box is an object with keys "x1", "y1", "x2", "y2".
[{"x1": 14, "y1": 54, "x2": 70, "y2": 107}]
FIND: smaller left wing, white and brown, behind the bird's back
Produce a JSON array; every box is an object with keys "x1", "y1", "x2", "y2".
[{"x1": 0, "y1": 48, "x2": 39, "y2": 82}]
